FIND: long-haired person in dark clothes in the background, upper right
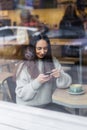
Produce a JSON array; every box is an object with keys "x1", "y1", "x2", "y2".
[{"x1": 59, "y1": 4, "x2": 85, "y2": 38}]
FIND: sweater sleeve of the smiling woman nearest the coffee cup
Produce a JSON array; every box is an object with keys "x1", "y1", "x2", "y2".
[{"x1": 54, "y1": 58, "x2": 72, "y2": 88}]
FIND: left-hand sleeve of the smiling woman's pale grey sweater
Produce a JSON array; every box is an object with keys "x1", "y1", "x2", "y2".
[{"x1": 15, "y1": 67, "x2": 41, "y2": 101}]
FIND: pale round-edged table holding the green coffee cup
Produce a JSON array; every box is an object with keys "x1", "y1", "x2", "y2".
[{"x1": 52, "y1": 85, "x2": 87, "y2": 115}]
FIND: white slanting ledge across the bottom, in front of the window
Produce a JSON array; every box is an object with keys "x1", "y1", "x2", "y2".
[{"x1": 0, "y1": 101, "x2": 87, "y2": 130}]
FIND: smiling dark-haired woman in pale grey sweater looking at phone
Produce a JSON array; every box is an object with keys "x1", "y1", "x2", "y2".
[{"x1": 16, "y1": 35, "x2": 72, "y2": 109}]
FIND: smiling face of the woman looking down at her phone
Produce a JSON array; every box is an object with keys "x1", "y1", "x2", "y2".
[{"x1": 36, "y1": 39, "x2": 48, "y2": 59}]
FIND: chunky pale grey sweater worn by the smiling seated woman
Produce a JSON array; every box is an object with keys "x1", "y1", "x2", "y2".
[{"x1": 15, "y1": 58, "x2": 72, "y2": 106}]
